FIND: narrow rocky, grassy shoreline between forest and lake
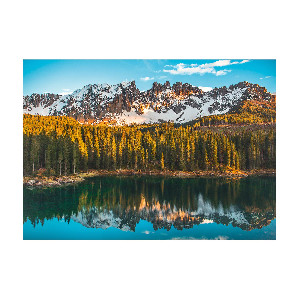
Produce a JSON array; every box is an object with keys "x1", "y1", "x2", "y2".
[{"x1": 23, "y1": 169, "x2": 276, "y2": 188}]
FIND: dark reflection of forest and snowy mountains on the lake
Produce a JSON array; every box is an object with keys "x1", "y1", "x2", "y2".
[{"x1": 24, "y1": 177, "x2": 276, "y2": 231}]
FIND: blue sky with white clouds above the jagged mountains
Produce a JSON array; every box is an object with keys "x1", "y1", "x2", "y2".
[{"x1": 23, "y1": 59, "x2": 276, "y2": 95}]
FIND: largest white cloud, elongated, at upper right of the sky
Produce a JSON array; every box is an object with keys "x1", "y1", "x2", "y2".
[{"x1": 163, "y1": 59, "x2": 249, "y2": 76}]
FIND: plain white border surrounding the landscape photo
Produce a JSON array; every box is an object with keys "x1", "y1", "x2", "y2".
[{"x1": 0, "y1": 0, "x2": 300, "y2": 300}]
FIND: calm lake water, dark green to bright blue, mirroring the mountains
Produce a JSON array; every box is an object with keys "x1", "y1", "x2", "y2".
[{"x1": 23, "y1": 176, "x2": 276, "y2": 240}]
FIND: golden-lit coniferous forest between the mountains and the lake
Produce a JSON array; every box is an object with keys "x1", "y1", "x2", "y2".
[{"x1": 23, "y1": 114, "x2": 276, "y2": 175}]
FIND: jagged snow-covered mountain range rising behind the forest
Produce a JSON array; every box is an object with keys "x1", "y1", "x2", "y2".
[{"x1": 23, "y1": 81, "x2": 276, "y2": 125}]
